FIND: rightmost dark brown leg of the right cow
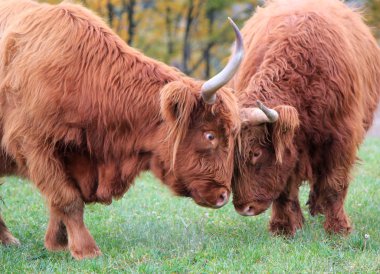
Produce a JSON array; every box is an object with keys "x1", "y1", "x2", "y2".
[{"x1": 309, "y1": 134, "x2": 360, "y2": 235}]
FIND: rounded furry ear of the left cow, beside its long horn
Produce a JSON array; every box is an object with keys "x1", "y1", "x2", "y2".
[{"x1": 160, "y1": 81, "x2": 196, "y2": 124}]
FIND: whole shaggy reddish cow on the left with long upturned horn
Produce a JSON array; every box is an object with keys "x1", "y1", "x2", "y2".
[{"x1": 0, "y1": 0, "x2": 242, "y2": 259}]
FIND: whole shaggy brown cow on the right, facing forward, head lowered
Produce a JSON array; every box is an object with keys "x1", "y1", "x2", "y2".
[{"x1": 232, "y1": 0, "x2": 380, "y2": 235}]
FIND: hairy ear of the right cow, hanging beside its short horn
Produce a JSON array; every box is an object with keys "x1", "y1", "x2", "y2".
[{"x1": 272, "y1": 105, "x2": 300, "y2": 163}]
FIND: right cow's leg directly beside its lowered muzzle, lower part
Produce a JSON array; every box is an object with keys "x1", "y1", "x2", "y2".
[{"x1": 269, "y1": 180, "x2": 304, "y2": 236}]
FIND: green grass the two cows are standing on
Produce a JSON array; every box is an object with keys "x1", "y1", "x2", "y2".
[{"x1": 0, "y1": 139, "x2": 380, "y2": 273}]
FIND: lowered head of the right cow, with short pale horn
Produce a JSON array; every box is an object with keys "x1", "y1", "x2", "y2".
[{"x1": 232, "y1": 101, "x2": 299, "y2": 216}]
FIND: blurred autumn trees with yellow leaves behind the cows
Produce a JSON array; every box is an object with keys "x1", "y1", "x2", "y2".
[{"x1": 40, "y1": 0, "x2": 380, "y2": 79}]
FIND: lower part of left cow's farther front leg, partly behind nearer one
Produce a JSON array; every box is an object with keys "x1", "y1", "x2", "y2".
[{"x1": 45, "y1": 210, "x2": 68, "y2": 251}]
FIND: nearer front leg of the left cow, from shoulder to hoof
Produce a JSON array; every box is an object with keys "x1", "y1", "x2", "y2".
[{"x1": 24, "y1": 144, "x2": 101, "y2": 259}]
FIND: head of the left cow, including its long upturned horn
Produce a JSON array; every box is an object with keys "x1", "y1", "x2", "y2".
[{"x1": 152, "y1": 18, "x2": 243, "y2": 208}]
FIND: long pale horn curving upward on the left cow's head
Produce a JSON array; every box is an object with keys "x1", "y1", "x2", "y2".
[{"x1": 201, "y1": 17, "x2": 244, "y2": 104}]
